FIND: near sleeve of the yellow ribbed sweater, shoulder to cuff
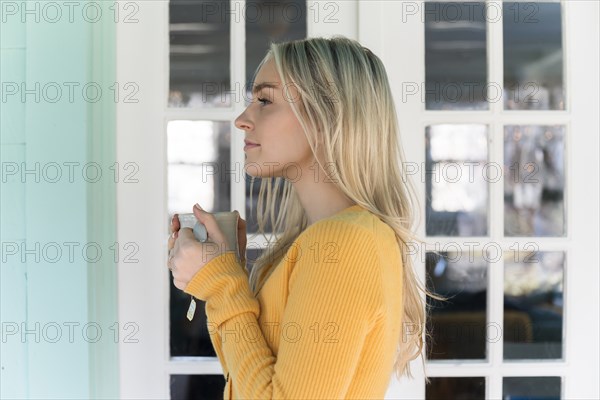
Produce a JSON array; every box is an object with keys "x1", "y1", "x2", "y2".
[{"x1": 185, "y1": 220, "x2": 382, "y2": 399}]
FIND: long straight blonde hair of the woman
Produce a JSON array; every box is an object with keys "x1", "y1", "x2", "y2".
[{"x1": 249, "y1": 35, "x2": 427, "y2": 378}]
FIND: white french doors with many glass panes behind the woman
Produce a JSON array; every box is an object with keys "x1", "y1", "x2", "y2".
[{"x1": 117, "y1": 0, "x2": 599, "y2": 399}]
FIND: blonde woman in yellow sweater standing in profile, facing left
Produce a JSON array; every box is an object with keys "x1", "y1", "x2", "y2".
[{"x1": 168, "y1": 36, "x2": 425, "y2": 399}]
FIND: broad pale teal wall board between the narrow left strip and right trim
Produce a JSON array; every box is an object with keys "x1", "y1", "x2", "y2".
[{"x1": 25, "y1": 10, "x2": 91, "y2": 398}]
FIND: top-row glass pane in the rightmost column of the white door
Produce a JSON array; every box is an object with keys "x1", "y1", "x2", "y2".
[{"x1": 503, "y1": 1, "x2": 565, "y2": 110}]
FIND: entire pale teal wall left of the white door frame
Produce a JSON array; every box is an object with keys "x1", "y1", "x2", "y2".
[{"x1": 0, "y1": 1, "x2": 118, "y2": 399}]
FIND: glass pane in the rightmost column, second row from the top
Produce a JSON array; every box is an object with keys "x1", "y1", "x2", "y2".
[{"x1": 504, "y1": 125, "x2": 566, "y2": 236}]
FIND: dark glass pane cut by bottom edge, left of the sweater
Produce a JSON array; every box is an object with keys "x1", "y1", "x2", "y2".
[{"x1": 170, "y1": 375, "x2": 226, "y2": 400}]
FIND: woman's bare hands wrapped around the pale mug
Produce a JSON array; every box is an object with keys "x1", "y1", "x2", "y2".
[{"x1": 167, "y1": 204, "x2": 234, "y2": 290}]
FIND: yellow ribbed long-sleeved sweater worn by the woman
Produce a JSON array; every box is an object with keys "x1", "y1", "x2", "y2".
[{"x1": 184, "y1": 205, "x2": 403, "y2": 400}]
